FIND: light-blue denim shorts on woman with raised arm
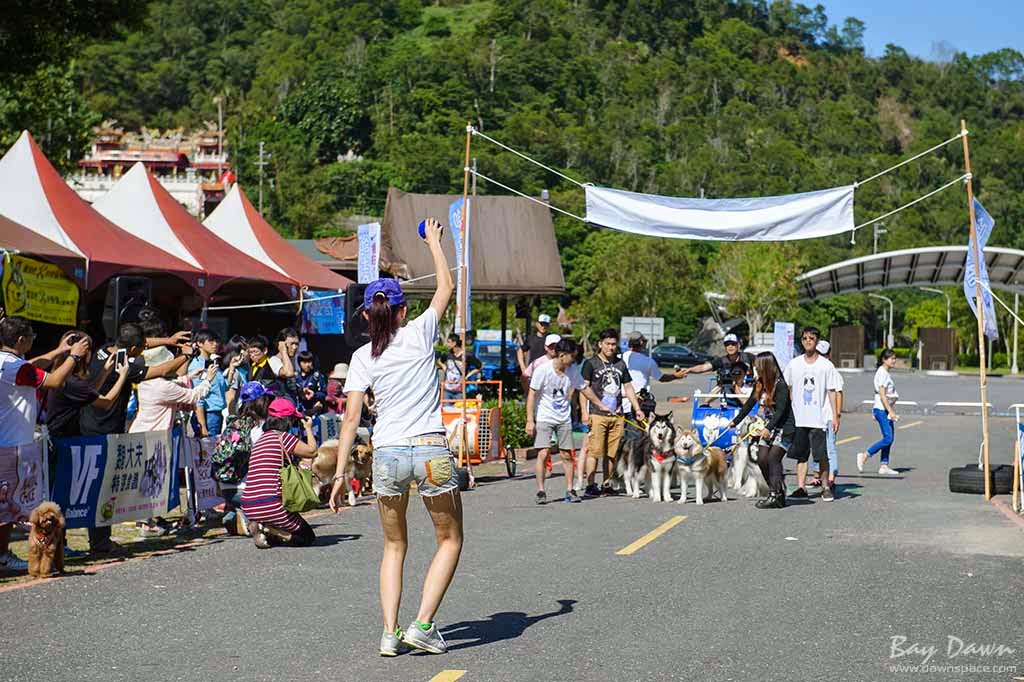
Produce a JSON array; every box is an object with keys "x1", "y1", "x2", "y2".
[{"x1": 374, "y1": 445, "x2": 459, "y2": 498}]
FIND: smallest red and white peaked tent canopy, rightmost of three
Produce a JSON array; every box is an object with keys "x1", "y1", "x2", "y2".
[{"x1": 203, "y1": 184, "x2": 352, "y2": 291}]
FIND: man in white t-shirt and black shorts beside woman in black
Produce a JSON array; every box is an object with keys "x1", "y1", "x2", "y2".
[{"x1": 782, "y1": 327, "x2": 840, "y2": 502}]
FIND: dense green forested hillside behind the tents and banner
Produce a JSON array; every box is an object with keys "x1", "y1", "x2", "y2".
[{"x1": 0, "y1": 0, "x2": 1024, "y2": 356}]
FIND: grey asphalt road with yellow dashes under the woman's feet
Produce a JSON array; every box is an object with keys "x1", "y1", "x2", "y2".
[{"x1": 0, "y1": 414, "x2": 1024, "y2": 682}]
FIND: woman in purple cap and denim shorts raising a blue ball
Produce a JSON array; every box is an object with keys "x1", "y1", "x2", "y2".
[{"x1": 331, "y1": 218, "x2": 462, "y2": 656}]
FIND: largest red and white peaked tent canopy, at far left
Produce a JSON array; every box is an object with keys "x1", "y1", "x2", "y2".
[{"x1": 0, "y1": 131, "x2": 205, "y2": 292}]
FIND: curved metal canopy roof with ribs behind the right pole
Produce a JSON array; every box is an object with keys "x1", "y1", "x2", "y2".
[{"x1": 797, "y1": 245, "x2": 1024, "y2": 301}]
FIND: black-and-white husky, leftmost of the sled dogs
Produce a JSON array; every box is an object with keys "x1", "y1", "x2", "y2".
[{"x1": 615, "y1": 413, "x2": 676, "y2": 502}]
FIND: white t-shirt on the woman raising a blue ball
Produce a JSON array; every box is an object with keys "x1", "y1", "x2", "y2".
[{"x1": 343, "y1": 308, "x2": 444, "y2": 447}]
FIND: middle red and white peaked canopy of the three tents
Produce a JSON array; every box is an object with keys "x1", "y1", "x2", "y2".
[{"x1": 92, "y1": 162, "x2": 298, "y2": 300}]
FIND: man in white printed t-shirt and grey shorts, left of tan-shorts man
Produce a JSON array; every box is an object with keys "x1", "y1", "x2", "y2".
[{"x1": 526, "y1": 339, "x2": 603, "y2": 505}]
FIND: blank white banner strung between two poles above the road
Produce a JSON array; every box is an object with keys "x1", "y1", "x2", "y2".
[{"x1": 586, "y1": 185, "x2": 854, "y2": 242}]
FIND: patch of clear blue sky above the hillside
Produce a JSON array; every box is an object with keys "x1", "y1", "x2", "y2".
[{"x1": 815, "y1": 0, "x2": 1024, "y2": 58}]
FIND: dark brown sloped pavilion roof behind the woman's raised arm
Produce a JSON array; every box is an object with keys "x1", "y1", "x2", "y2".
[{"x1": 381, "y1": 187, "x2": 565, "y2": 298}]
